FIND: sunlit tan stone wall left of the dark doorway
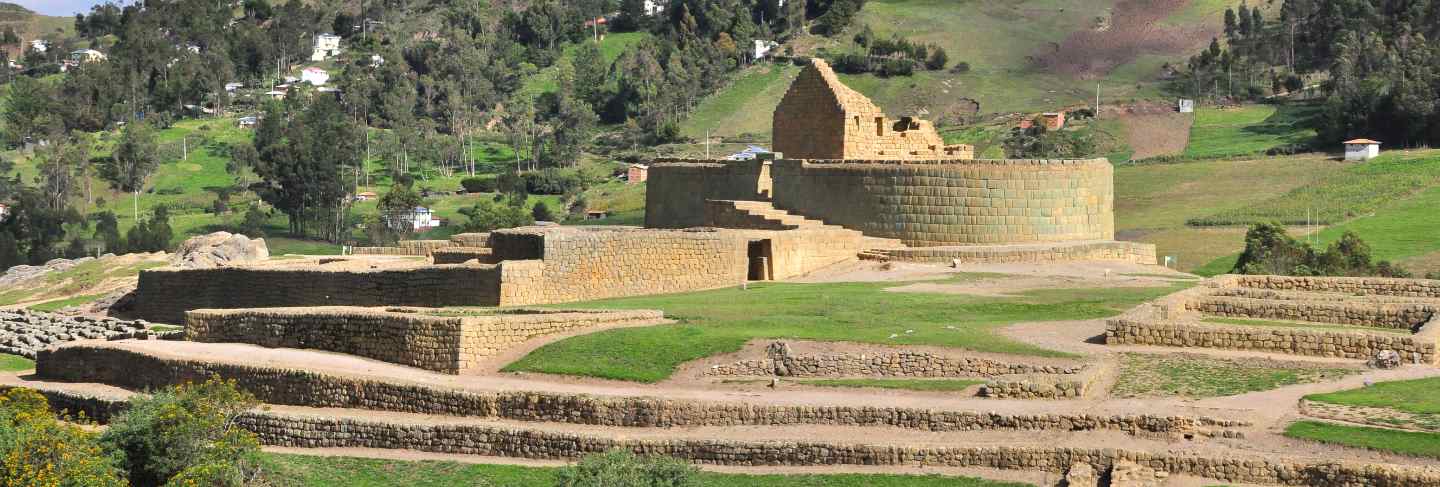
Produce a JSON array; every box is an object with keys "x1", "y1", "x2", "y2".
[{"x1": 491, "y1": 228, "x2": 747, "y2": 305}]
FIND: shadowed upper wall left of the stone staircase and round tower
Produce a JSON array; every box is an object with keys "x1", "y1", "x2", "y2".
[{"x1": 645, "y1": 158, "x2": 770, "y2": 228}]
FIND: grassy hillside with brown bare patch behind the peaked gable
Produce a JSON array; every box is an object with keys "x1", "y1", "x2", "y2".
[{"x1": 684, "y1": 0, "x2": 1238, "y2": 137}]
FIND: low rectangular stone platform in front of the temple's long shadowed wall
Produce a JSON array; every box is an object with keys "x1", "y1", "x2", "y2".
[{"x1": 186, "y1": 307, "x2": 664, "y2": 373}]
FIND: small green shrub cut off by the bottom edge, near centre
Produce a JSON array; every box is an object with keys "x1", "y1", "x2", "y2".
[{"x1": 556, "y1": 450, "x2": 700, "y2": 487}]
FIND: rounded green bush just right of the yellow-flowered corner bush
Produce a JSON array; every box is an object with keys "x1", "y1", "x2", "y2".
[{"x1": 101, "y1": 377, "x2": 259, "y2": 487}]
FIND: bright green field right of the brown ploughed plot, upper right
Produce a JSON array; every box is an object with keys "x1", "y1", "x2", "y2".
[{"x1": 1184, "y1": 105, "x2": 1316, "y2": 158}]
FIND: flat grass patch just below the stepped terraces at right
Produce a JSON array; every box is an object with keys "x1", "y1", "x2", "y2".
[{"x1": 1110, "y1": 353, "x2": 1359, "y2": 398}]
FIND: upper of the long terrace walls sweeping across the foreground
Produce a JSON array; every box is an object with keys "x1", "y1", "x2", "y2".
[{"x1": 36, "y1": 344, "x2": 1248, "y2": 437}]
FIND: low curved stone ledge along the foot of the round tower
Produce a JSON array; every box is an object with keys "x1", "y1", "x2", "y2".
[{"x1": 884, "y1": 241, "x2": 1155, "y2": 265}]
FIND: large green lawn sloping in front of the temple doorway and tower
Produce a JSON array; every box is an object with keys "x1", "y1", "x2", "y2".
[{"x1": 504, "y1": 282, "x2": 1182, "y2": 382}]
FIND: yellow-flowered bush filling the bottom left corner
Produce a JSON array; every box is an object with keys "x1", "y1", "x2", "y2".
[{"x1": 0, "y1": 388, "x2": 125, "y2": 487}]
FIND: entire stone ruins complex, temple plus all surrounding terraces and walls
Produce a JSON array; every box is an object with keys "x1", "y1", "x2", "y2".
[{"x1": 4, "y1": 61, "x2": 1440, "y2": 487}]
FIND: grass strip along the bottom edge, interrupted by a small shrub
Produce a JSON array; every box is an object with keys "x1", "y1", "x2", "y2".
[{"x1": 261, "y1": 454, "x2": 1025, "y2": 487}]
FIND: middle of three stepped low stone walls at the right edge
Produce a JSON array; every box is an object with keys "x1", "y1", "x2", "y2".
[{"x1": 1187, "y1": 297, "x2": 1437, "y2": 330}]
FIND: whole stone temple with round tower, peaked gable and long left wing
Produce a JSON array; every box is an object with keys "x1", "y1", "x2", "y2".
[{"x1": 135, "y1": 61, "x2": 1155, "y2": 323}]
